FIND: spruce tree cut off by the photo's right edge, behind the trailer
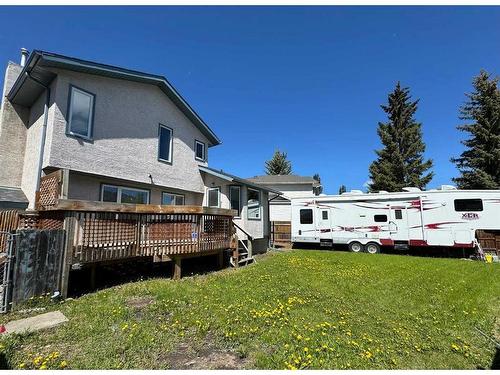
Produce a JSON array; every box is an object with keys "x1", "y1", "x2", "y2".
[{"x1": 451, "y1": 71, "x2": 500, "y2": 189}]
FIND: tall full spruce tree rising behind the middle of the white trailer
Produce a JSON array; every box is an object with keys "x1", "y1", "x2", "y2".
[{"x1": 369, "y1": 82, "x2": 434, "y2": 192}]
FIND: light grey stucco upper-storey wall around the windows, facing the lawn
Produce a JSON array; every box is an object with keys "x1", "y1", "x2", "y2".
[{"x1": 48, "y1": 70, "x2": 208, "y2": 194}]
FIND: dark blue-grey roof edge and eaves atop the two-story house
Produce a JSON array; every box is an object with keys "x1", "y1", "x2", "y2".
[{"x1": 7, "y1": 50, "x2": 221, "y2": 146}]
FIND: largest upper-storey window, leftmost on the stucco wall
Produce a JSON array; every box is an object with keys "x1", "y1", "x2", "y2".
[{"x1": 67, "y1": 86, "x2": 95, "y2": 139}]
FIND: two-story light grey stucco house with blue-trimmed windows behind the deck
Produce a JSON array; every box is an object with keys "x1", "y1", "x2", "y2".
[{"x1": 0, "y1": 50, "x2": 278, "y2": 251}]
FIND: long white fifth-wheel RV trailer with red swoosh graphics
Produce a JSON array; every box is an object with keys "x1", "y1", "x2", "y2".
[{"x1": 291, "y1": 185, "x2": 500, "y2": 253}]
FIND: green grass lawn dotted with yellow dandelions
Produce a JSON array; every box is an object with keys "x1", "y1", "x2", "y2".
[{"x1": 2, "y1": 250, "x2": 500, "y2": 369}]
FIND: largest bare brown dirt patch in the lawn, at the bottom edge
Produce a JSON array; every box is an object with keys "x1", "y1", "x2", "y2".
[{"x1": 163, "y1": 339, "x2": 247, "y2": 370}]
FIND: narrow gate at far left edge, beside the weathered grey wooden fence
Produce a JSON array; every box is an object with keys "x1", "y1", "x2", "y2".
[{"x1": 0, "y1": 232, "x2": 16, "y2": 314}]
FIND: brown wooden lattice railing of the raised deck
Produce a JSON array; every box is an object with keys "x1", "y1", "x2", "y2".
[{"x1": 39, "y1": 199, "x2": 236, "y2": 264}]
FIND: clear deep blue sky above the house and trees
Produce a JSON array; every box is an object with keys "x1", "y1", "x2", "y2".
[{"x1": 0, "y1": 6, "x2": 500, "y2": 193}]
